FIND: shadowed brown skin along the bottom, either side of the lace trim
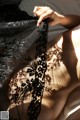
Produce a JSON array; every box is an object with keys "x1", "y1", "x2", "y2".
[{"x1": 7, "y1": 82, "x2": 80, "y2": 120}]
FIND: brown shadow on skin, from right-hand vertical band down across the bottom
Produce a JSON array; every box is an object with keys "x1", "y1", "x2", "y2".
[{"x1": 0, "y1": 27, "x2": 80, "y2": 120}]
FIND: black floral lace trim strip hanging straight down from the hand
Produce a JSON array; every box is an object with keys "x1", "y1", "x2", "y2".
[{"x1": 10, "y1": 20, "x2": 47, "y2": 120}]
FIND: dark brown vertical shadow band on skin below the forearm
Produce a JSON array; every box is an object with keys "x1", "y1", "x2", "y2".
[{"x1": 62, "y1": 31, "x2": 78, "y2": 82}]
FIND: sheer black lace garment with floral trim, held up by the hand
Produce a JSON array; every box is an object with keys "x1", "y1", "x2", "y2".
[{"x1": 0, "y1": 5, "x2": 48, "y2": 120}]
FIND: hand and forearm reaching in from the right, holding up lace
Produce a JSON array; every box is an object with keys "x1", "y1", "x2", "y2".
[{"x1": 33, "y1": 6, "x2": 80, "y2": 28}]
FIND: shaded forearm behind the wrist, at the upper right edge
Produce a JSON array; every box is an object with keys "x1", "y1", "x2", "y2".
[{"x1": 60, "y1": 15, "x2": 80, "y2": 28}]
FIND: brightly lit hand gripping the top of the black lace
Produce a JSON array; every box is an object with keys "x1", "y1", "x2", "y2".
[{"x1": 33, "y1": 6, "x2": 64, "y2": 26}]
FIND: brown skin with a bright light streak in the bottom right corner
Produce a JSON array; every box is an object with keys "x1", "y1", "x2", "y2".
[{"x1": 57, "y1": 87, "x2": 80, "y2": 120}]
